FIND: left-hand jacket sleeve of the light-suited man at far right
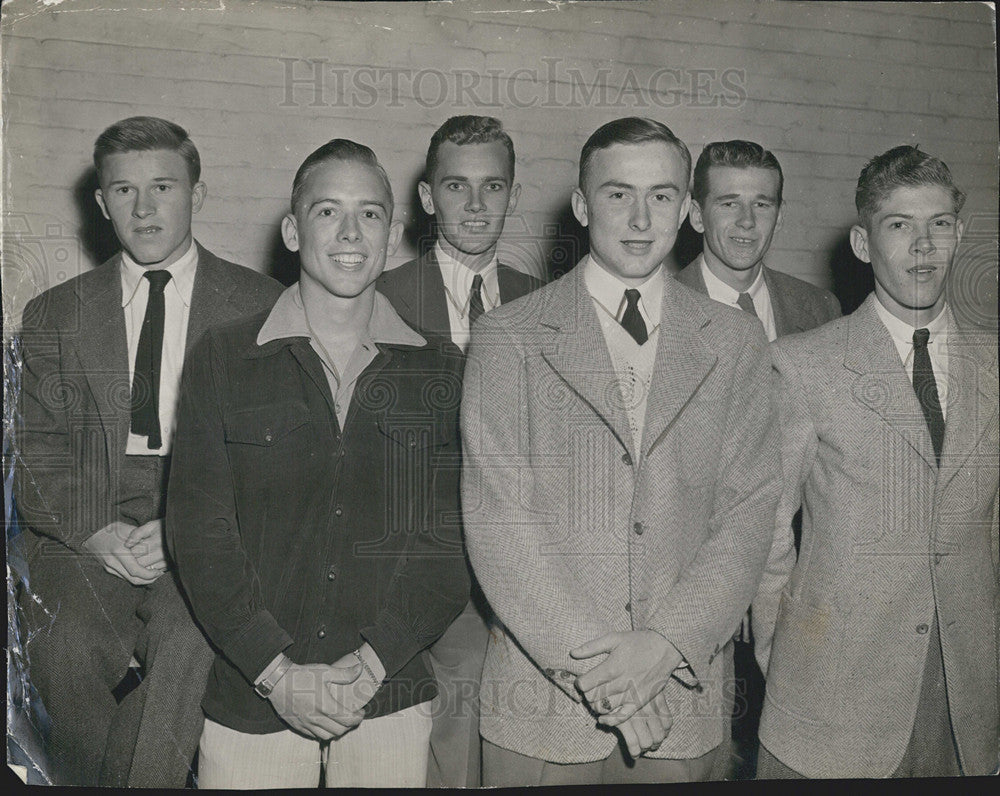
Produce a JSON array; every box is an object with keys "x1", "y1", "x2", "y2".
[{"x1": 750, "y1": 344, "x2": 817, "y2": 675}]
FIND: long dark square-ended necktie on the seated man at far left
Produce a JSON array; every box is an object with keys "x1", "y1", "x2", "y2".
[{"x1": 132, "y1": 270, "x2": 170, "y2": 450}]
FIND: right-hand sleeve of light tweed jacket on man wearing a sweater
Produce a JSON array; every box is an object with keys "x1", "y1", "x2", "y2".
[{"x1": 648, "y1": 325, "x2": 780, "y2": 681}]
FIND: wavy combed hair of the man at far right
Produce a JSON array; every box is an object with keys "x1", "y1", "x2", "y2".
[{"x1": 854, "y1": 144, "x2": 965, "y2": 229}]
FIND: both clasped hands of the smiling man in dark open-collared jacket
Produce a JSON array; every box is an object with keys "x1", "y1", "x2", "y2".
[{"x1": 268, "y1": 644, "x2": 384, "y2": 741}]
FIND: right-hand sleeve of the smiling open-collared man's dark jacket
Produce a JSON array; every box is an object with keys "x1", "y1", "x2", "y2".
[{"x1": 361, "y1": 349, "x2": 470, "y2": 678}]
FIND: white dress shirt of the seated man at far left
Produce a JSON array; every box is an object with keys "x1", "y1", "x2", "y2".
[{"x1": 121, "y1": 240, "x2": 198, "y2": 456}]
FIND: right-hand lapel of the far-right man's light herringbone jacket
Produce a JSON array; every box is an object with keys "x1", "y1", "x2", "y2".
[{"x1": 938, "y1": 319, "x2": 998, "y2": 490}]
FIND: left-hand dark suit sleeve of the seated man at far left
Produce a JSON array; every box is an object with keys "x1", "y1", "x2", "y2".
[{"x1": 9, "y1": 294, "x2": 116, "y2": 552}]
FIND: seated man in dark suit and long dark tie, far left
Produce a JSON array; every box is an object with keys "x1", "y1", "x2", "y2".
[{"x1": 15, "y1": 117, "x2": 281, "y2": 787}]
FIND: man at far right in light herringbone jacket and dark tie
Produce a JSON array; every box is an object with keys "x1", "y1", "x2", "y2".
[{"x1": 753, "y1": 146, "x2": 1000, "y2": 778}]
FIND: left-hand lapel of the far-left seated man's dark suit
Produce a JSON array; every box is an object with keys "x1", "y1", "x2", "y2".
[{"x1": 76, "y1": 255, "x2": 131, "y2": 472}]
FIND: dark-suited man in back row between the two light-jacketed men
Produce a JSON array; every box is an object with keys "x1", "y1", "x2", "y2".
[{"x1": 677, "y1": 141, "x2": 840, "y2": 777}]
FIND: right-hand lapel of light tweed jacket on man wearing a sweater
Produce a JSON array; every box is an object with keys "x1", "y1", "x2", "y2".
[{"x1": 642, "y1": 278, "x2": 718, "y2": 456}]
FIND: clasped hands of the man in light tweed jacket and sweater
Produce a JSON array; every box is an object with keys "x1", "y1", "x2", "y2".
[{"x1": 569, "y1": 630, "x2": 683, "y2": 759}]
